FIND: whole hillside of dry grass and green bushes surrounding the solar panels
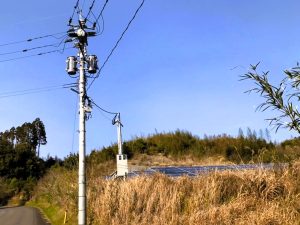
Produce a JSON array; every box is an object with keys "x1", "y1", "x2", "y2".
[{"x1": 29, "y1": 131, "x2": 300, "y2": 225}]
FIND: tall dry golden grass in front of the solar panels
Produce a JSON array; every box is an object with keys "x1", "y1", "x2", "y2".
[{"x1": 31, "y1": 163, "x2": 300, "y2": 225}]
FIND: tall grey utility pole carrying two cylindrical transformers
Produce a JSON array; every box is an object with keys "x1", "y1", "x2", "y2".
[{"x1": 67, "y1": 15, "x2": 98, "y2": 225}]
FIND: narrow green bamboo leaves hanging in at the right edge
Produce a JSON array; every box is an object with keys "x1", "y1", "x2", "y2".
[{"x1": 241, "y1": 63, "x2": 300, "y2": 133}]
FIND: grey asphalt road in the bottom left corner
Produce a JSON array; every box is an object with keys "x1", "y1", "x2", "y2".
[{"x1": 0, "y1": 206, "x2": 50, "y2": 225}]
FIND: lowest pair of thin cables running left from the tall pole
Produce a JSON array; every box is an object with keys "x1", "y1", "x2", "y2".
[{"x1": 0, "y1": 83, "x2": 77, "y2": 99}]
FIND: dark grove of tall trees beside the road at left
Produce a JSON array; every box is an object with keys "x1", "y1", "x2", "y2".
[{"x1": 0, "y1": 118, "x2": 57, "y2": 205}]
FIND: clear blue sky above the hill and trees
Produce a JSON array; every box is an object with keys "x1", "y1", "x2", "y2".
[{"x1": 0, "y1": 0, "x2": 300, "y2": 157}]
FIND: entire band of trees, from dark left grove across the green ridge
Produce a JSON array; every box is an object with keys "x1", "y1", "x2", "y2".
[{"x1": 0, "y1": 118, "x2": 300, "y2": 205}]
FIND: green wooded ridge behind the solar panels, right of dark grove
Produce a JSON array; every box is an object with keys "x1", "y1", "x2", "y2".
[{"x1": 82, "y1": 128, "x2": 300, "y2": 168}]
